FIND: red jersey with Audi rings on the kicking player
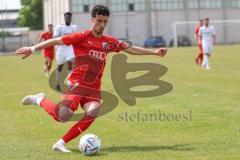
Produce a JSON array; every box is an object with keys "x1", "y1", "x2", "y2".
[{"x1": 62, "y1": 30, "x2": 120, "y2": 89}]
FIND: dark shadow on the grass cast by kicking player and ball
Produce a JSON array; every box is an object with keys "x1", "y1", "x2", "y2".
[{"x1": 71, "y1": 144, "x2": 195, "y2": 156}]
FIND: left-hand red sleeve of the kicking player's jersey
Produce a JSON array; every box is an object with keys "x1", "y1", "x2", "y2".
[{"x1": 62, "y1": 32, "x2": 85, "y2": 46}]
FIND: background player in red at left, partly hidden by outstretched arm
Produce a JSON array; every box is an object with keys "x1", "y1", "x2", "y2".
[{"x1": 39, "y1": 24, "x2": 54, "y2": 76}]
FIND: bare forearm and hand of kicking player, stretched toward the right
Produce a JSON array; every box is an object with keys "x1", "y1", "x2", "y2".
[{"x1": 123, "y1": 46, "x2": 167, "y2": 57}]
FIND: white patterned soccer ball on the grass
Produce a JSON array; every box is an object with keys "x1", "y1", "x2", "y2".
[{"x1": 79, "y1": 134, "x2": 101, "y2": 156}]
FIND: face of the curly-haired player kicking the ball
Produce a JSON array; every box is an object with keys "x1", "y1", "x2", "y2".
[{"x1": 92, "y1": 15, "x2": 109, "y2": 34}]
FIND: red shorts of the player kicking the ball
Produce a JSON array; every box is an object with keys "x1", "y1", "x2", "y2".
[{"x1": 59, "y1": 85, "x2": 101, "y2": 112}]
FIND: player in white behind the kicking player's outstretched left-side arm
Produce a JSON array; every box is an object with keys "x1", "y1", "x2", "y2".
[{"x1": 53, "y1": 12, "x2": 77, "y2": 91}]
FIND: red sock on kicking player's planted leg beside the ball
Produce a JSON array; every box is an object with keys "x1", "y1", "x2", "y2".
[{"x1": 62, "y1": 115, "x2": 95, "y2": 143}]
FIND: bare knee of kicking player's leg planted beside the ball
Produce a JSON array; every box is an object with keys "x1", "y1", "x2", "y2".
[{"x1": 84, "y1": 101, "x2": 99, "y2": 118}]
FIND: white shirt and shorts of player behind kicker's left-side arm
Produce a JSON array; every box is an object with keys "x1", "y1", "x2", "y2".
[{"x1": 53, "y1": 24, "x2": 77, "y2": 65}]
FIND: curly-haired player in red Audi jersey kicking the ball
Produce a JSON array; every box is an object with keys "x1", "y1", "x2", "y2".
[{"x1": 16, "y1": 5, "x2": 167, "y2": 152}]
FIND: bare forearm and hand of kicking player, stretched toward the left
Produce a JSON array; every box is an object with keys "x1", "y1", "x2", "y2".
[{"x1": 15, "y1": 37, "x2": 64, "y2": 59}]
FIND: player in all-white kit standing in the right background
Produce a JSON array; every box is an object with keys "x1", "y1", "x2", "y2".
[{"x1": 199, "y1": 18, "x2": 216, "y2": 70}]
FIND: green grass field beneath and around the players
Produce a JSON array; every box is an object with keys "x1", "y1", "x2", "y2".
[{"x1": 0, "y1": 46, "x2": 240, "y2": 160}]
